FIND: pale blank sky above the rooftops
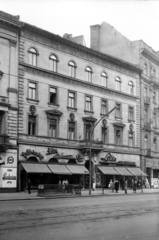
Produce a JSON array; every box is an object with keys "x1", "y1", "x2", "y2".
[{"x1": 0, "y1": 0, "x2": 159, "y2": 51}]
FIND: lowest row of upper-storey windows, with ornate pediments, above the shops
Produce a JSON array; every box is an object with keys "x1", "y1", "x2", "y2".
[{"x1": 28, "y1": 115, "x2": 135, "y2": 147}]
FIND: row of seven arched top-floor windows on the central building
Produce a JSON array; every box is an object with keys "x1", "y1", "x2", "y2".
[{"x1": 29, "y1": 48, "x2": 134, "y2": 95}]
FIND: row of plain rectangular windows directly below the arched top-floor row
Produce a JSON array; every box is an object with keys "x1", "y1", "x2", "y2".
[{"x1": 29, "y1": 82, "x2": 134, "y2": 118}]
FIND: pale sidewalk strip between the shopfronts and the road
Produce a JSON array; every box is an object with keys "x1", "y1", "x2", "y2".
[{"x1": 0, "y1": 189, "x2": 159, "y2": 201}]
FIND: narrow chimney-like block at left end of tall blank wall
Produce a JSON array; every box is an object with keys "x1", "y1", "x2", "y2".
[{"x1": 90, "y1": 24, "x2": 100, "y2": 51}]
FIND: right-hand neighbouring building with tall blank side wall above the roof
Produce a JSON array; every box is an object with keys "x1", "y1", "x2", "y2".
[{"x1": 91, "y1": 22, "x2": 159, "y2": 182}]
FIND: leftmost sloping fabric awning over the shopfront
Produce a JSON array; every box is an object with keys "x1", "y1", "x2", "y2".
[{"x1": 21, "y1": 163, "x2": 51, "y2": 173}]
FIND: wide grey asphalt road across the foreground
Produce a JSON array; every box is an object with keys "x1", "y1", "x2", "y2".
[{"x1": 0, "y1": 194, "x2": 159, "y2": 240}]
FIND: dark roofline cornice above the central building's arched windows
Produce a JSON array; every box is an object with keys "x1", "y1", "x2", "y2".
[{"x1": 23, "y1": 23, "x2": 142, "y2": 74}]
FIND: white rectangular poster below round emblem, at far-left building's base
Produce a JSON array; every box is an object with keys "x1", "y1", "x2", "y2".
[{"x1": 2, "y1": 168, "x2": 17, "y2": 188}]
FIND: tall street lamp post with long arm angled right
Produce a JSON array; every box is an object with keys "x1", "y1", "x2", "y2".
[{"x1": 89, "y1": 107, "x2": 116, "y2": 195}]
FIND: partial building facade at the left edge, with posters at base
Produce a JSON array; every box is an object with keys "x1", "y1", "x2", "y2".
[{"x1": 0, "y1": 12, "x2": 21, "y2": 192}]
